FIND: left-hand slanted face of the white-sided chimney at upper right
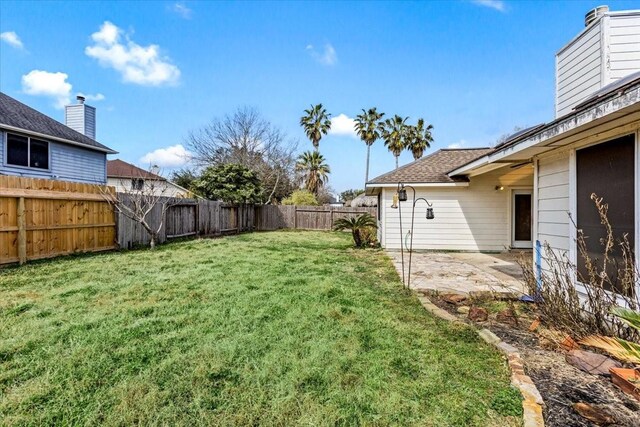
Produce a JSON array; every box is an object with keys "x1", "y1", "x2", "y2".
[{"x1": 556, "y1": 22, "x2": 602, "y2": 117}]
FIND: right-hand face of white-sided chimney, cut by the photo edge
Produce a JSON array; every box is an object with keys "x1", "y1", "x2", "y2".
[{"x1": 607, "y1": 14, "x2": 640, "y2": 82}]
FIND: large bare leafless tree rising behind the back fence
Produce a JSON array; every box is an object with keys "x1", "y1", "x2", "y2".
[{"x1": 186, "y1": 107, "x2": 297, "y2": 203}]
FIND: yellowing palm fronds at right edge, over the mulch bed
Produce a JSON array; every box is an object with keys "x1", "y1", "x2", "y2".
[{"x1": 580, "y1": 307, "x2": 640, "y2": 365}]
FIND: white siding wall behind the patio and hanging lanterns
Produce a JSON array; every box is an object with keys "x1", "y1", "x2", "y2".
[{"x1": 379, "y1": 165, "x2": 533, "y2": 251}]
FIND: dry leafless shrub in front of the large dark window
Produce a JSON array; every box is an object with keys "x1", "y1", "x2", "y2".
[{"x1": 520, "y1": 194, "x2": 640, "y2": 342}]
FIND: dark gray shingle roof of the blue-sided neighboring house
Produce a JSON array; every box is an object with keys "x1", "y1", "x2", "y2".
[{"x1": 0, "y1": 92, "x2": 116, "y2": 154}]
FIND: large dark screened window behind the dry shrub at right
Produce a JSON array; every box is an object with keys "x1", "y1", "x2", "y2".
[{"x1": 576, "y1": 135, "x2": 635, "y2": 289}]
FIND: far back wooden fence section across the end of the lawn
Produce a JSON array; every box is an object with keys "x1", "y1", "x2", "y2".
[{"x1": 255, "y1": 205, "x2": 378, "y2": 230}]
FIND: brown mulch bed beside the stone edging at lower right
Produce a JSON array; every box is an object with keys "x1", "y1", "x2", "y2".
[{"x1": 431, "y1": 296, "x2": 640, "y2": 427}]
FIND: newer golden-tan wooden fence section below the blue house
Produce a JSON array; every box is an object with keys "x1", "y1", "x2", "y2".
[{"x1": 0, "y1": 176, "x2": 116, "y2": 264}]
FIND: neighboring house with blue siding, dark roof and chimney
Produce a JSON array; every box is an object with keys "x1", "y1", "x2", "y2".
[{"x1": 0, "y1": 92, "x2": 116, "y2": 184}]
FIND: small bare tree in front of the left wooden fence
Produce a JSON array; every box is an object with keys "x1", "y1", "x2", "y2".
[{"x1": 103, "y1": 174, "x2": 173, "y2": 250}]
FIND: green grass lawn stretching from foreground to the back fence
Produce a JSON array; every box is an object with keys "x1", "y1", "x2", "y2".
[{"x1": 0, "y1": 232, "x2": 521, "y2": 426}]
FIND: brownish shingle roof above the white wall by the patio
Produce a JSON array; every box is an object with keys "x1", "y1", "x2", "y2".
[{"x1": 367, "y1": 148, "x2": 493, "y2": 187}]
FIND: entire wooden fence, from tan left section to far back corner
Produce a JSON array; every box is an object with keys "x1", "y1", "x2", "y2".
[{"x1": 0, "y1": 176, "x2": 377, "y2": 264}]
